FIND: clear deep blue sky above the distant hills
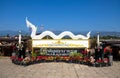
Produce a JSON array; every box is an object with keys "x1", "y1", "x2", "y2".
[{"x1": 0, "y1": 0, "x2": 120, "y2": 32}]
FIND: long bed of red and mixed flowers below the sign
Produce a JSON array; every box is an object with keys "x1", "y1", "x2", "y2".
[{"x1": 11, "y1": 53, "x2": 109, "y2": 67}]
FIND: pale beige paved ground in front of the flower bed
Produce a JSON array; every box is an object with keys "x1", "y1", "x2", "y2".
[{"x1": 0, "y1": 57, "x2": 120, "y2": 78}]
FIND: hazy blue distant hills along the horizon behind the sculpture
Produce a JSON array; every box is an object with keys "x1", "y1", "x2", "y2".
[{"x1": 0, "y1": 30, "x2": 120, "y2": 37}]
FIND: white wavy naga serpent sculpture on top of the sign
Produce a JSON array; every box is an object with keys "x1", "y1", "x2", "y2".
[{"x1": 26, "y1": 18, "x2": 90, "y2": 39}]
